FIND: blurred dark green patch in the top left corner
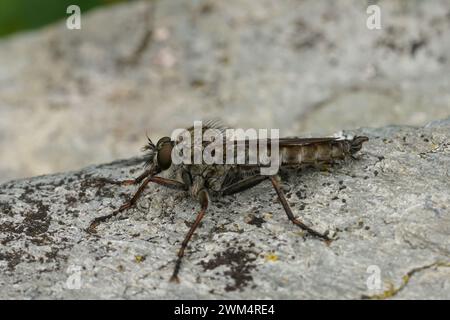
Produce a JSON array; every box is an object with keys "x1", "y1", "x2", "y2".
[{"x1": 0, "y1": 0, "x2": 131, "y2": 37}]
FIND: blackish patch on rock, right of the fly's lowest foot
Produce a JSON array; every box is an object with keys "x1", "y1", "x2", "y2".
[{"x1": 200, "y1": 247, "x2": 257, "y2": 291}]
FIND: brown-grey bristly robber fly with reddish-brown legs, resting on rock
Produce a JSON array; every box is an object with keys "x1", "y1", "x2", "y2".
[{"x1": 88, "y1": 122, "x2": 368, "y2": 282}]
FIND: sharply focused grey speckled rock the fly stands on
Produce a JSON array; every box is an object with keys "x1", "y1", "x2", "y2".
[{"x1": 0, "y1": 119, "x2": 450, "y2": 299}]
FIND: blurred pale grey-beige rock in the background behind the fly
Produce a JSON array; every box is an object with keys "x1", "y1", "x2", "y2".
[{"x1": 0, "y1": 0, "x2": 450, "y2": 181}]
